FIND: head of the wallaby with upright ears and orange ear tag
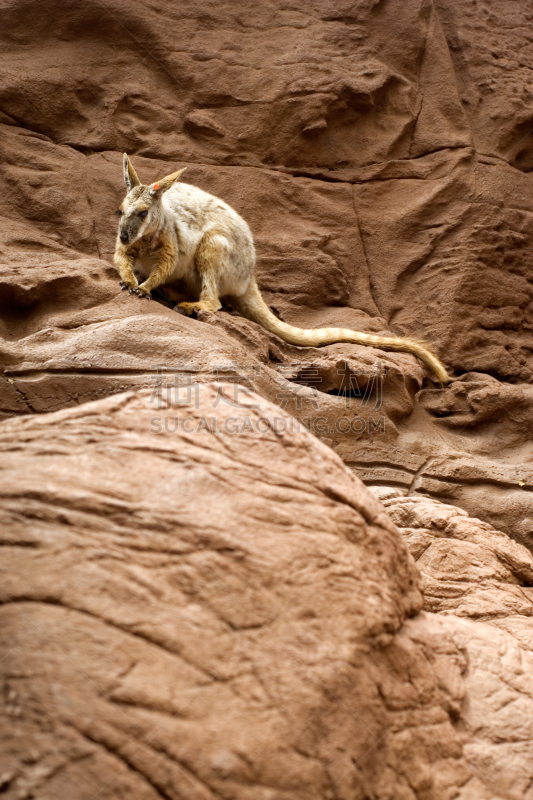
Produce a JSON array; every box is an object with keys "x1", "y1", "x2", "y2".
[{"x1": 117, "y1": 153, "x2": 186, "y2": 245}]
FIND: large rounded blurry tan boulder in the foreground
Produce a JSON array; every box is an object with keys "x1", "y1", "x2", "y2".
[{"x1": 0, "y1": 384, "x2": 533, "y2": 800}]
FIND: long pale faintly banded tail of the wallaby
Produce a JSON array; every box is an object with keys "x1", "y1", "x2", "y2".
[{"x1": 236, "y1": 280, "x2": 451, "y2": 383}]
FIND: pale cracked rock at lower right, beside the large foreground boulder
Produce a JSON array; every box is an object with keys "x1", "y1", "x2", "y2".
[{"x1": 380, "y1": 488, "x2": 533, "y2": 800}]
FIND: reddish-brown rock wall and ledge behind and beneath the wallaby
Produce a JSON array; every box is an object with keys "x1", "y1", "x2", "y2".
[{"x1": 0, "y1": 0, "x2": 533, "y2": 547}]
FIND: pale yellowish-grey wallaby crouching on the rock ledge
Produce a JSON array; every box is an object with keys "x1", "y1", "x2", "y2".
[{"x1": 114, "y1": 154, "x2": 450, "y2": 383}]
